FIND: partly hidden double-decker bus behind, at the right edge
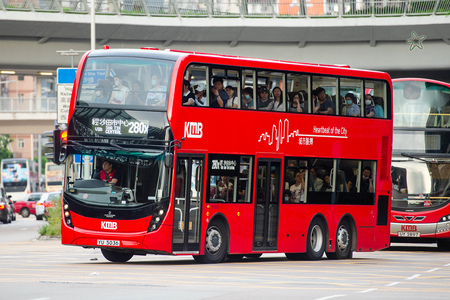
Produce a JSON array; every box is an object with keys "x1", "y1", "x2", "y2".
[{"x1": 391, "y1": 78, "x2": 450, "y2": 249}]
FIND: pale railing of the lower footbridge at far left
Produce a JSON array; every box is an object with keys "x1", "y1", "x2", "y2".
[{"x1": 0, "y1": 97, "x2": 57, "y2": 113}]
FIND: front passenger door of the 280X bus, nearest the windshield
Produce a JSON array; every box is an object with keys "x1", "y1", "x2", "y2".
[{"x1": 172, "y1": 155, "x2": 204, "y2": 253}]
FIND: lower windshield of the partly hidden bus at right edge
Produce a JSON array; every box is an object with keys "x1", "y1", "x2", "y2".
[{"x1": 391, "y1": 160, "x2": 450, "y2": 211}]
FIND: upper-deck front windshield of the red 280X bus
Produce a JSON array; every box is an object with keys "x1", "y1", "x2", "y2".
[{"x1": 77, "y1": 56, "x2": 174, "y2": 110}]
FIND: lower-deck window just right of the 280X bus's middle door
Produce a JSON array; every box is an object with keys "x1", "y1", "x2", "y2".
[{"x1": 283, "y1": 158, "x2": 308, "y2": 203}]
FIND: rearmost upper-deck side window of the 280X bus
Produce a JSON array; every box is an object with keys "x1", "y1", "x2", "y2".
[{"x1": 364, "y1": 80, "x2": 390, "y2": 119}]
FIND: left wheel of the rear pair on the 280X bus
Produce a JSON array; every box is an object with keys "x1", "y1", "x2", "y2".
[{"x1": 305, "y1": 218, "x2": 327, "y2": 260}]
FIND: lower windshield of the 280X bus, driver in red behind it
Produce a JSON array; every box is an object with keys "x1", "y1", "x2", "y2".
[{"x1": 65, "y1": 151, "x2": 169, "y2": 207}]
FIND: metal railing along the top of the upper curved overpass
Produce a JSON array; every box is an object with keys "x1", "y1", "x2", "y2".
[{"x1": 0, "y1": 0, "x2": 450, "y2": 18}]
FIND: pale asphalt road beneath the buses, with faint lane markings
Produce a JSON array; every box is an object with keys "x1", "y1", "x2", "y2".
[{"x1": 0, "y1": 216, "x2": 450, "y2": 300}]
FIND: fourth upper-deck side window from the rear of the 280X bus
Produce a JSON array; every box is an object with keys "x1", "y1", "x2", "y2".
[{"x1": 286, "y1": 73, "x2": 312, "y2": 113}]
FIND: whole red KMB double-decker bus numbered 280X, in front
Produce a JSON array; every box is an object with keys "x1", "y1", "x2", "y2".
[{"x1": 57, "y1": 49, "x2": 392, "y2": 262}]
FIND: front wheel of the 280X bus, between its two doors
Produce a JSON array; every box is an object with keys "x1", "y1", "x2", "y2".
[{"x1": 194, "y1": 221, "x2": 228, "y2": 264}]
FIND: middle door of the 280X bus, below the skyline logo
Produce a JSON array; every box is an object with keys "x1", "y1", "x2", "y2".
[{"x1": 253, "y1": 159, "x2": 281, "y2": 251}]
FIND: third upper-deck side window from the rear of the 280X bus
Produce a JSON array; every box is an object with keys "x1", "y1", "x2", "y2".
[{"x1": 312, "y1": 76, "x2": 339, "y2": 115}]
